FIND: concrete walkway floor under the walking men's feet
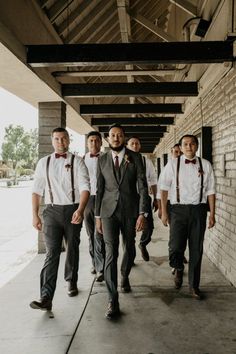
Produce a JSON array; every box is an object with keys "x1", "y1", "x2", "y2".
[{"x1": 0, "y1": 220, "x2": 236, "y2": 354}]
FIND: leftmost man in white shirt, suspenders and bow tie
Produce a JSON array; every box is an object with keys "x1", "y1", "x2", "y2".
[{"x1": 30, "y1": 128, "x2": 90, "y2": 310}]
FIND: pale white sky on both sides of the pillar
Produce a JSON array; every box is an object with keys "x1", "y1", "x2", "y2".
[{"x1": 0, "y1": 87, "x2": 85, "y2": 156}]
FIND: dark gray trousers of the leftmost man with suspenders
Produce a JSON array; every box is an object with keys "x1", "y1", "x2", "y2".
[{"x1": 40, "y1": 204, "x2": 82, "y2": 300}]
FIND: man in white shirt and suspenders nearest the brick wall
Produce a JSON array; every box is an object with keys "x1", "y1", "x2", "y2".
[{"x1": 160, "y1": 135, "x2": 215, "y2": 299}]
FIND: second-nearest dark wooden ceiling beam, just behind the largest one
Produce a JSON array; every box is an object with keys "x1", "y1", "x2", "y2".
[{"x1": 62, "y1": 82, "x2": 198, "y2": 97}]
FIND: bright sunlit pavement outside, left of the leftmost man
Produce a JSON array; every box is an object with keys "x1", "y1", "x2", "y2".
[{"x1": 0, "y1": 181, "x2": 37, "y2": 287}]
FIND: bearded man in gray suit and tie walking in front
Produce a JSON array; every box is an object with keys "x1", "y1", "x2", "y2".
[{"x1": 95, "y1": 124, "x2": 148, "y2": 319}]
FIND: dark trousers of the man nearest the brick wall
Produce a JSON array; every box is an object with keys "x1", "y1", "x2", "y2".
[{"x1": 169, "y1": 204, "x2": 207, "y2": 288}]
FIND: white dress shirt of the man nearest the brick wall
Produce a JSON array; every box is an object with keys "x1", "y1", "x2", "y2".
[{"x1": 160, "y1": 155, "x2": 215, "y2": 205}]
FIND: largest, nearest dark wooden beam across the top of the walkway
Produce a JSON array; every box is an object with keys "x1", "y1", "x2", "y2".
[{"x1": 26, "y1": 38, "x2": 234, "y2": 67}]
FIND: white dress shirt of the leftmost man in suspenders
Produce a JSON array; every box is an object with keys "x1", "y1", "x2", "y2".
[{"x1": 32, "y1": 152, "x2": 90, "y2": 205}]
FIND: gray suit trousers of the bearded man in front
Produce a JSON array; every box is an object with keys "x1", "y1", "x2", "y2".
[{"x1": 102, "y1": 207, "x2": 136, "y2": 304}]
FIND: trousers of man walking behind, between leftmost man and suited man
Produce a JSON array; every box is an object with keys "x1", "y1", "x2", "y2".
[{"x1": 84, "y1": 195, "x2": 105, "y2": 272}]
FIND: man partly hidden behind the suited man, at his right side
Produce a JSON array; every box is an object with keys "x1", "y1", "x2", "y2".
[{"x1": 127, "y1": 136, "x2": 158, "y2": 262}]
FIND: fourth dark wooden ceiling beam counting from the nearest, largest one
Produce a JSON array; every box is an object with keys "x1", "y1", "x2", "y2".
[{"x1": 91, "y1": 117, "x2": 174, "y2": 126}]
